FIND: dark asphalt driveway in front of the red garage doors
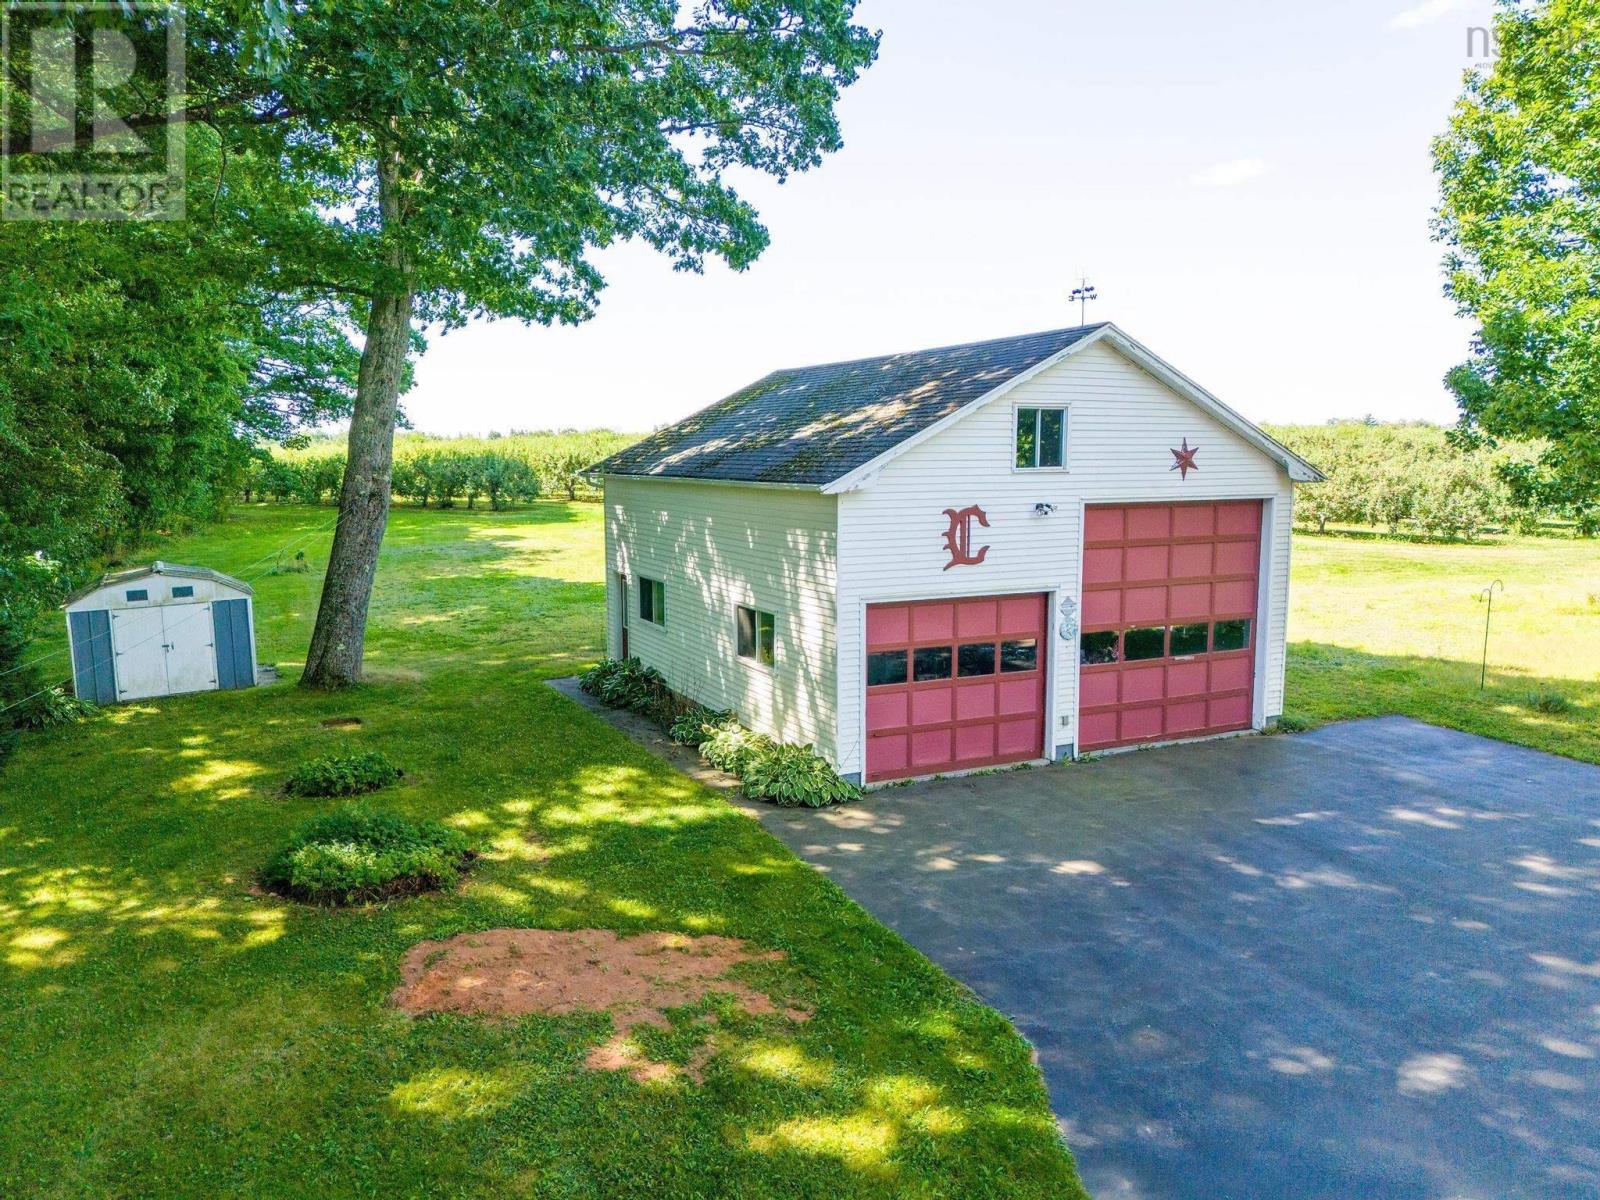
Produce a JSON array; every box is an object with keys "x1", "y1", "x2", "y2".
[{"x1": 752, "y1": 718, "x2": 1600, "y2": 1200}]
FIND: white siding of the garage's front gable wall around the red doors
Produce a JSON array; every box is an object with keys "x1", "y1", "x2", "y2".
[{"x1": 837, "y1": 346, "x2": 1293, "y2": 773}]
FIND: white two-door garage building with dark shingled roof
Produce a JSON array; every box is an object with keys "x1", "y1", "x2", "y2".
[{"x1": 594, "y1": 325, "x2": 1322, "y2": 782}]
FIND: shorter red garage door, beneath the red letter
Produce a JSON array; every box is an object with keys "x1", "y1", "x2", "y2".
[{"x1": 867, "y1": 595, "x2": 1046, "y2": 782}]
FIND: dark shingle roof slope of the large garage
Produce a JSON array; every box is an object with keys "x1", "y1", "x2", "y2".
[{"x1": 590, "y1": 325, "x2": 1101, "y2": 486}]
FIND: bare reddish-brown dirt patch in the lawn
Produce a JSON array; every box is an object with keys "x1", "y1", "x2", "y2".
[{"x1": 389, "y1": 930, "x2": 810, "y2": 1083}]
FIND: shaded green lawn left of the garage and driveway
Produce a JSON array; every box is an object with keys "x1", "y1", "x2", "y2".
[{"x1": 0, "y1": 502, "x2": 1082, "y2": 1200}]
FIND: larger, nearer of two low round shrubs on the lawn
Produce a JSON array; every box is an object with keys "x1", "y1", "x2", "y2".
[{"x1": 261, "y1": 806, "x2": 474, "y2": 904}]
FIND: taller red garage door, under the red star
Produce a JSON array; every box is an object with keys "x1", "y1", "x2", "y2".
[{"x1": 1078, "y1": 501, "x2": 1261, "y2": 750}]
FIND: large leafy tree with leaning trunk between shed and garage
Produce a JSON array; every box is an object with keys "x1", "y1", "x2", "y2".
[{"x1": 168, "y1": 0, "x2": 877, "y2": 686}]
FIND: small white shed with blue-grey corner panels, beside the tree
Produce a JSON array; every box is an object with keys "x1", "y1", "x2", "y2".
[{"x1": 62, "y1": 562, "x2": 256, "y2": 704}]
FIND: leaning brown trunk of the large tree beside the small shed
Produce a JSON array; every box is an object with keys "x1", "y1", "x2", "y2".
[{"x1": 301, "y1": 158, "x2": 414, "y2": 688}]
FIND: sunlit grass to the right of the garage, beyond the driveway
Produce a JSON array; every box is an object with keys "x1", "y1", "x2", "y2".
[{"x1": 1288, "y1": 538, "x2": 1600, "y2": 763}]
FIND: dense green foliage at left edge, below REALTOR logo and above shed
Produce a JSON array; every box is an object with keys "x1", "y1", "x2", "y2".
[{"x1": 0, "y1": 138, "x2": 357, "y2": 752}]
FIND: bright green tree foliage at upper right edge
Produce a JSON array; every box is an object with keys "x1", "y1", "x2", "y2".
[{"x1": 1434, "y1": 0, "x2": 1600, "y2": 531}]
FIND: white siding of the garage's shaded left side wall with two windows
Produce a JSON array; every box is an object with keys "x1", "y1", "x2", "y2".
[{"x1": 605, "y1": 475, "x2": 838, "y2": 757}]
